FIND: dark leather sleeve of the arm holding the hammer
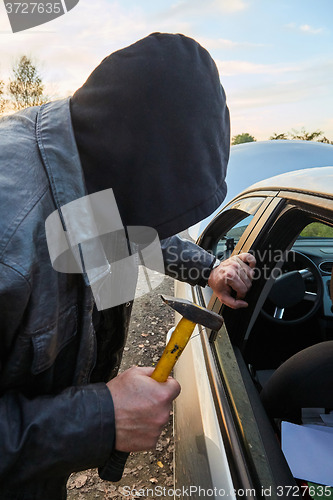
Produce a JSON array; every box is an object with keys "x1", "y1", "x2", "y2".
[{"x1": 0, "y1": 264, "x2": 115, "y2": 484}]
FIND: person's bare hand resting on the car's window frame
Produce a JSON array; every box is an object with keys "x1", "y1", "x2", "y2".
[{"x1": 208, "y1": 253, "x2": 256, "y2": 309}]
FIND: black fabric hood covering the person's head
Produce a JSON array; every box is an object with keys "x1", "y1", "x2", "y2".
[{"x1": 71, "y1": 33, "x2": 230, "y2": 239}]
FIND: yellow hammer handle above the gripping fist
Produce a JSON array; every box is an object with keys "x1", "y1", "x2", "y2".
[{"x1": 151, "y1": 318, "x2": 196, "y2": 382}]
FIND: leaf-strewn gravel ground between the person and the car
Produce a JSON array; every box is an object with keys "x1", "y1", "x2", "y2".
[{"x1": 67, "y1": 277, "x2": 174, "y2": 500}]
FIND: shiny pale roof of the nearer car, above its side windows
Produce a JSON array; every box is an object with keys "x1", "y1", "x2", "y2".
[{"x1": 243, "y1": 166, "x2": 333, "y2": 198}]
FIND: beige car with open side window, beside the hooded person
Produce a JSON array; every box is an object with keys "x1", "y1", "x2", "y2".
[{"x1": 174, "y1": 154, "x2": 333, "y2": 499}]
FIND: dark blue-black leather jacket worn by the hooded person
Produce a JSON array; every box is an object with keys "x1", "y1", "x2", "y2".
[{"x1": 0, "y1": 96, "x2": 214, "y2": 500}]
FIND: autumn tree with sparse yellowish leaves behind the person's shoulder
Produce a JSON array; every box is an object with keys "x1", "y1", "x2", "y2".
[{"x1": 8, "y1": 56, "x2": 46, "y2": 110}]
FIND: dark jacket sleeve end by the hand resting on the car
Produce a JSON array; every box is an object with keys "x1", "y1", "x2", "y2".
[{"x1": 161, "y1": 235, "x2": 216, "y2": 286}]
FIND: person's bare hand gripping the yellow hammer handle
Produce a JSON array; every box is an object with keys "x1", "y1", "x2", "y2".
[{"x1": 107, "y1": 366, "x2": 180, "y2": 452}]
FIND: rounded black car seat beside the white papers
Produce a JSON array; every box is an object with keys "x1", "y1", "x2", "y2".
[{"x1": 260, "y1": 270, "x2": 333, "y2": 423}]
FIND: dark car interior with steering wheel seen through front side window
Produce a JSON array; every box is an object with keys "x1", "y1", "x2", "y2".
[{"x1": 244, "y1": 222, "x2": 333, "y2": 406}]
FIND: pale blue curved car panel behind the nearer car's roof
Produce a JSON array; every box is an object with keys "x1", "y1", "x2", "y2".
[{"x1": 189, "y1": 140, "x2": 333, "y2": 240}]
